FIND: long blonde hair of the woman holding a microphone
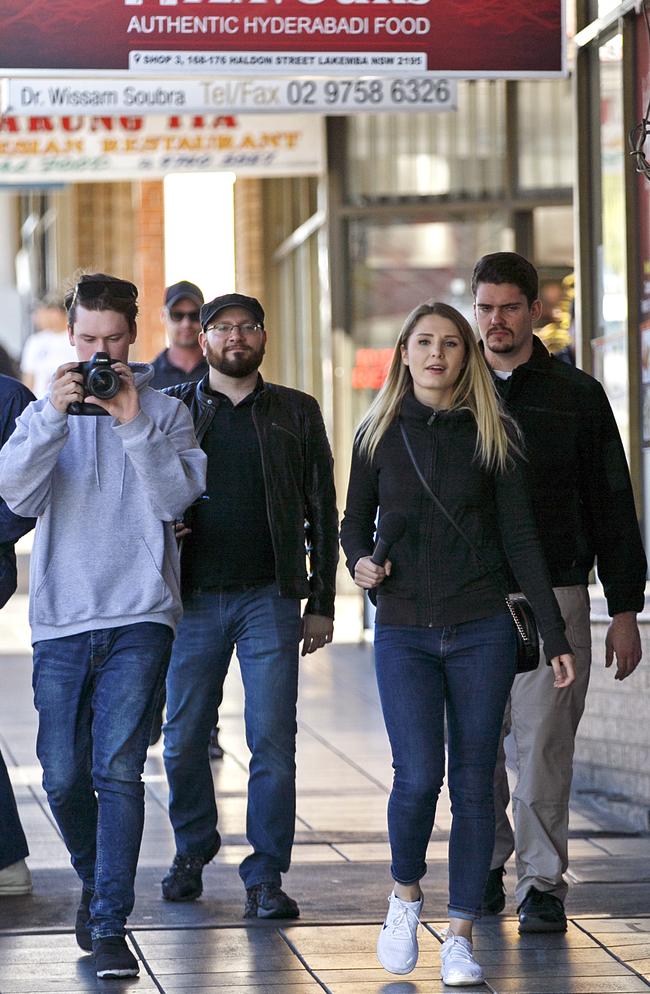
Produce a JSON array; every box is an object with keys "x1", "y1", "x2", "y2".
[{"x1": 356, "y1": 300, "x2": 520, "y2": 471}]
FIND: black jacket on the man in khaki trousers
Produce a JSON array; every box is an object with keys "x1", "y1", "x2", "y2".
[{"x1": 488, "y1": 335, "x2": 646, "y2": 616}]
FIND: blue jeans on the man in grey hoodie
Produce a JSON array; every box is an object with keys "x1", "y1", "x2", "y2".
[{"x1": 33, "y1": 622, "x2": 173, "y2": 939}]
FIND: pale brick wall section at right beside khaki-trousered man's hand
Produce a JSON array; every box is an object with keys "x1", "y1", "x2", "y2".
[{"x1": 574, "y1": 620, "x2": 650, "y2": 831}]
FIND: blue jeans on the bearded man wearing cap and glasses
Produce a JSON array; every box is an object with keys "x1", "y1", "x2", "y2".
[{"x1": 164, "y1": 584, "x2": 300, "y2": 887}]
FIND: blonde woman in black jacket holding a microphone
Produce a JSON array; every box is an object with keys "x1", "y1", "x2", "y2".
[{"x1": 341, "y1": 301, "x2": 574, "y2": 986}]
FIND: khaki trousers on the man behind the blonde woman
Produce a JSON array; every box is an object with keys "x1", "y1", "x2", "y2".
[{"x1": 492, "y1": 586, "x2": 591, "y2": 906}]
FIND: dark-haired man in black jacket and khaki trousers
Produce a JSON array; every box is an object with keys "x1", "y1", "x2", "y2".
[{"x1": 472, "y1": 252, "x2": 646, "y2": 932}]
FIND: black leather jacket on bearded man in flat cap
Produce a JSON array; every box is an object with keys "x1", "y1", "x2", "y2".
[{"x1": 163, "y1": 375, "x2": 338, "y2": 618}]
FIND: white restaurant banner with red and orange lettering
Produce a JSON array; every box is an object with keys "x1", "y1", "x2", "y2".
[{"x1": 0, "y1": 114, "x2": 325, "y2": 184}]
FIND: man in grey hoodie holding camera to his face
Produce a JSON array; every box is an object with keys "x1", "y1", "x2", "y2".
[{"x1": 0, "y1": 273, "x2": 206, "y2": 977}]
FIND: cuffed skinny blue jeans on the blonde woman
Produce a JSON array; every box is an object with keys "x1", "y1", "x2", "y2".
[{"x1": 375, "y1": 614, "x2": 516, "y2": 920}]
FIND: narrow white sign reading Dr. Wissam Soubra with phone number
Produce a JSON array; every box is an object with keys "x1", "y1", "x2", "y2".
[{"x1": 0, "y1": 75, "x2": 457, "y2": 115}]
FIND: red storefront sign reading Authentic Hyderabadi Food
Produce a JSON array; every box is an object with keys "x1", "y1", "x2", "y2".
[{"x1": 0, "y1": 0, "x2": 564, "y2": 77}]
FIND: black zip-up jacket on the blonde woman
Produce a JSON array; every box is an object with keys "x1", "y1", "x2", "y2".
[{"x1": 341, "y1": 393, "x2": 571, "y2": 659}]
